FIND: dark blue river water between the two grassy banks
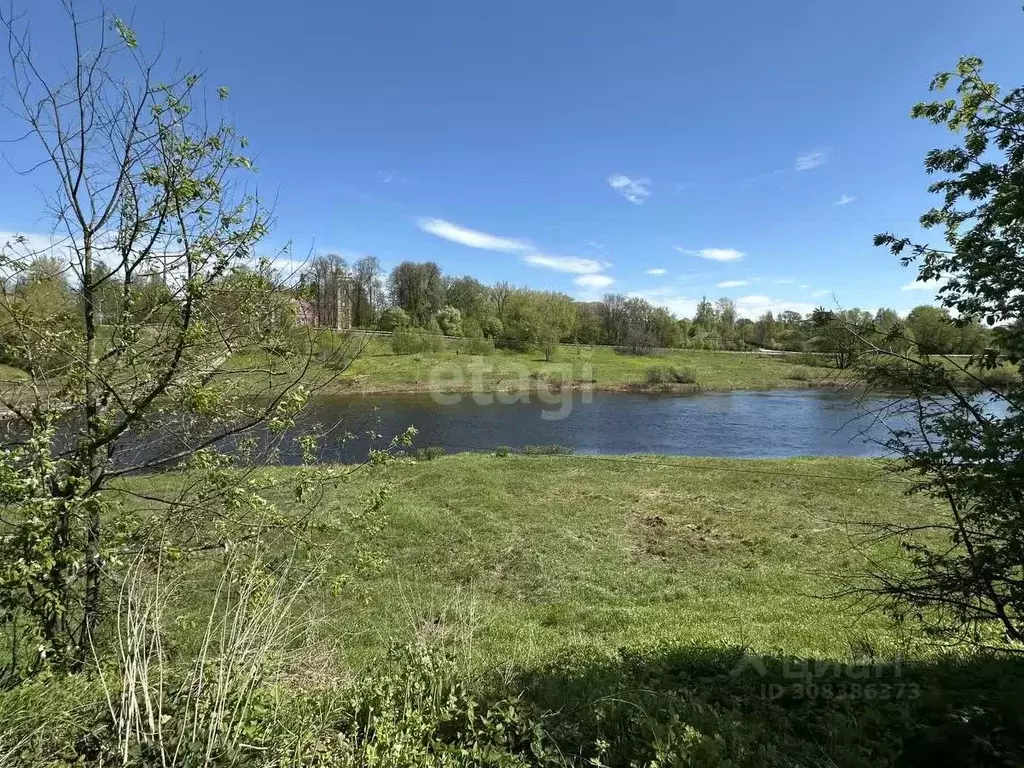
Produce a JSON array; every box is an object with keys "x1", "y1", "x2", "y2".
[{"x1": 285, "y1": 389, "x2": 921, "y2": 461}]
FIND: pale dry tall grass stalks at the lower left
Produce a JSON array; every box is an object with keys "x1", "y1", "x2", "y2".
[{"x1": 100, "y1": 555, "x2": 327, "y2": 767}]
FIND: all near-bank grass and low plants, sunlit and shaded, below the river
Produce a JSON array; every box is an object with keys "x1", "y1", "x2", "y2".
[{"x1": 8, "y1": 455, "x2": 1024, "y2": 766}]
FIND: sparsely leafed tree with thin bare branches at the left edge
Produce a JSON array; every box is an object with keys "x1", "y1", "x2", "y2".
[{"x1": 0, "y1": 0, "x2": 391, "y2": 667}]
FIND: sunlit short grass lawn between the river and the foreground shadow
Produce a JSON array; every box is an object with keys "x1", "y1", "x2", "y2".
[{"x1": 150, "y1": 454, "x2": 933, "y2": 667}]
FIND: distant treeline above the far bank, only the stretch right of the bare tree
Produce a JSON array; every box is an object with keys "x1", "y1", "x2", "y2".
[{"x1": 303, "y1": 256, "x2": 996, "y2": 354}]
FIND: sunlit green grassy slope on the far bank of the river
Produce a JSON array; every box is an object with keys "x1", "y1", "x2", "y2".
[{"x1": 331, "y1": 339, "x2": 836, "y2": 392}]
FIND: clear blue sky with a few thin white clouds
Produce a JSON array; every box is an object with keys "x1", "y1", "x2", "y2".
[{"x1": 0, "y1": 0, "x2": 1024, "y2": 315}]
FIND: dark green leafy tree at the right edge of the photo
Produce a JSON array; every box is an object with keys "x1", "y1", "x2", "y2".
[{"x1": 861, "y1": 52, "x2": 1024, "y2": 651}]
